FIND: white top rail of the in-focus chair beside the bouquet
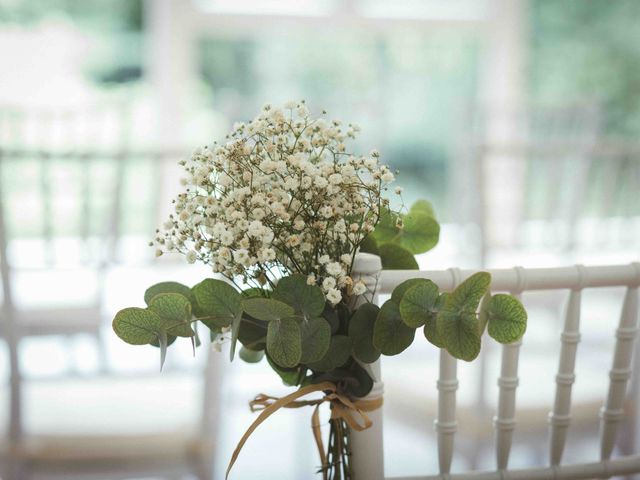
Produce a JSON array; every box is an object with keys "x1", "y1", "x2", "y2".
[{"x1": 378, "y1": 262, "x2": 640, "y2": 294}]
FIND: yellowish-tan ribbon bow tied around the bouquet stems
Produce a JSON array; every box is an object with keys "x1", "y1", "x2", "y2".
[{"x1": 225, "y1": 382, "x2": 382, "y2": 479}]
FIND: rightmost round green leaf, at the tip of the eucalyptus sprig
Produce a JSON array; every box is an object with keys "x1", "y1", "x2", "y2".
[{"x1": 488, "y1": 293, "x2": 527, "y2": 343}]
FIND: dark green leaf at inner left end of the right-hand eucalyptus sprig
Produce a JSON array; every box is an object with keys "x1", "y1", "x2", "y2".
[{"x1": 373, "y1": 300, "x2": 416, "y2": 355}]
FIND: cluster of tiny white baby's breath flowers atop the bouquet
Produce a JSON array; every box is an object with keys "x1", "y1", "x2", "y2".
[{"x1": 155, "y1": 101, "x2": 394, "y2": 304}]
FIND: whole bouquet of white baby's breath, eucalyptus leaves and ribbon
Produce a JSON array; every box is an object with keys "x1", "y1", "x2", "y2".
[{"x1": 113, "y1": 101, "x2": 527, "y2": 479}]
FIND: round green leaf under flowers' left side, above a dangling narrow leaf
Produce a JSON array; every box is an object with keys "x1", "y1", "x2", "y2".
[{"x1": 191, "y1": 278, "x2": 242, "y2": 328}]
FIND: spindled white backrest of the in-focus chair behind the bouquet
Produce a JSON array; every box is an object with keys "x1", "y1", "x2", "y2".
[{"x1": 353, "y1": 256, "x2": 640, "y2": 480}]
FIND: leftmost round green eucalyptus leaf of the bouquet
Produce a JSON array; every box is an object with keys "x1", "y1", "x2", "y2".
[{"x1": 112, "y1": 307, "x2": 171, "y2": 345}]
